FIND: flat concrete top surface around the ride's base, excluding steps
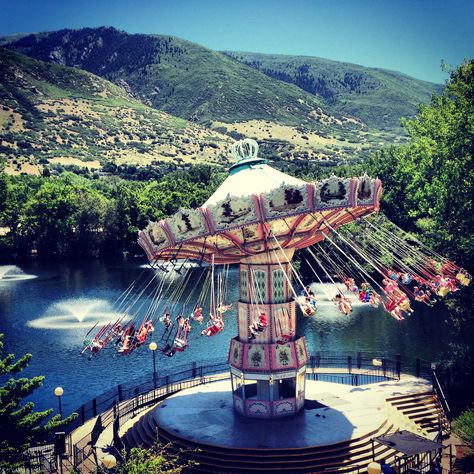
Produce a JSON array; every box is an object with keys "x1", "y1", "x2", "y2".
[{"x1": 153, "y1": 376, "x2": 431, "y2": 449}]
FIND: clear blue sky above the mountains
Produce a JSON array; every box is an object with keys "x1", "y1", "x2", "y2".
[{"x1": 0, "y1": 0, "x2": 474, "y2": 82}]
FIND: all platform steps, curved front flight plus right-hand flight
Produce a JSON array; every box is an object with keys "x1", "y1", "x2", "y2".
[{"x1": 122, "y1": 391, "x2": 449, "y2": 474}]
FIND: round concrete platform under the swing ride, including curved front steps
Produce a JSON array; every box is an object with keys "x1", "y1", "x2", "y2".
[{"x1": 121, "y1": 375, "x2": 433, "y2": 473}]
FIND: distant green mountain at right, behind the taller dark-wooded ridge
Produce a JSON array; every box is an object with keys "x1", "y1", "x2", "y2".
[{"x1": 224, "y1": 51, "x2": 442, "y2": 129}]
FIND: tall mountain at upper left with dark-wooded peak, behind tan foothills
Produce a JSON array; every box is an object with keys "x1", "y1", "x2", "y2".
[{"x1": 6, "y1": 27, "x2": 353, "y2": 129}]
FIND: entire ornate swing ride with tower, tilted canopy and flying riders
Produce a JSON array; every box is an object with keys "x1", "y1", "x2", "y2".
[{"x1": 83, "y1": 139, "x2": 471, "y2": 418}]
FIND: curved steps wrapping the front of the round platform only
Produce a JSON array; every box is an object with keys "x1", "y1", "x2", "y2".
[{"x1": 122, "y1": 411, "x2": 404, "y2": 473}]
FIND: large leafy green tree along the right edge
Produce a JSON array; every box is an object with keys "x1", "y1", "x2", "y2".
[{"x1": 369, "y1": 59, "x2": 474, "y2": 411}]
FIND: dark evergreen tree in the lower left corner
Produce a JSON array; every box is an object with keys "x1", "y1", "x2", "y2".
[{"x1": 0, "y1": 334, "x2": 77, "y2": 473}]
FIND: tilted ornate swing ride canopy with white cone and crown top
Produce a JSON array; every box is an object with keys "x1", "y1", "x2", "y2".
[{"x1": 138, "y1": 139, "x2": 382, "y2": 264}]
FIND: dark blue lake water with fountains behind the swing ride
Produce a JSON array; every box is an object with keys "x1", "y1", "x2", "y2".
[{"x1": 0, "y1": 259, "x2": 450, "y2": 413}]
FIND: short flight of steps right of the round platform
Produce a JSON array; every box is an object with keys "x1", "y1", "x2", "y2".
[{"x1": 386, "y1": 391, "x2": 450, "y2": 438}]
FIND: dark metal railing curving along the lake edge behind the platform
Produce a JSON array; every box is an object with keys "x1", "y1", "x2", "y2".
[{"x1": 21, "y1": 352, "x2": 444, "y2": 472}]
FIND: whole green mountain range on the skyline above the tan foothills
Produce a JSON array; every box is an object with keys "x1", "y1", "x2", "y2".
[{"x1": 3, "y1": 27, "x2": 441, "y2": 131}]
